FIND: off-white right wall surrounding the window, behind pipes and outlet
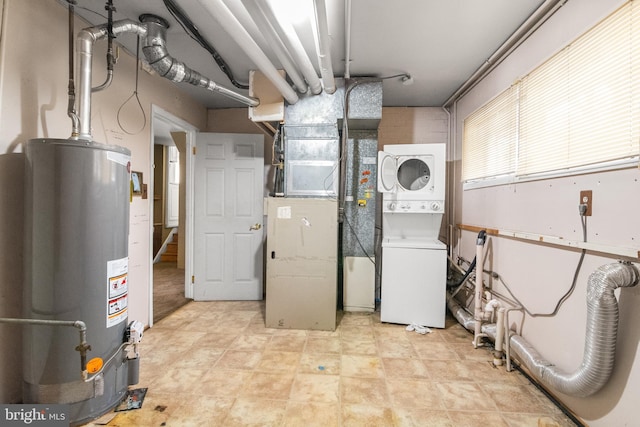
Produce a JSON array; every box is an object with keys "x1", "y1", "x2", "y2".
[{"x1": 450, "y1": 0, "x2": 640, "y2": 427}]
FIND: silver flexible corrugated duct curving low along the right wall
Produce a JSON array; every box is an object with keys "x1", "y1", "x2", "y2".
[{"x1": 447, "y1": 263, "x2": 640, "y2": 397}]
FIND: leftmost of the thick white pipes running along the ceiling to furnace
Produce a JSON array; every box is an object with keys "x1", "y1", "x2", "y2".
[{"x1": 198, "y1": 0, "x2": 299, "y2": 104}]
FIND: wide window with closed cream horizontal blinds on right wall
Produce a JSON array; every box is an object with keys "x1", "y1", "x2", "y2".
[{"x1": 462, "y1": 2, "x2": 640, "y2": 185}]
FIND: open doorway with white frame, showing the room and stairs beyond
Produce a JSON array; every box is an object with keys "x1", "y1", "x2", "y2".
[{"x1": 149, "y1": 106, "x2": 196, "y2": 326}]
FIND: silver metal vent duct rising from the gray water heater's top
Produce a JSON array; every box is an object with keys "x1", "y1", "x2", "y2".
[{"x1": 76, "y1": 15, "x2": 259, "y2": 140}]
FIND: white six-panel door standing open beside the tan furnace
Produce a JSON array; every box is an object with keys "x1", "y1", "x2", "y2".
[{"x1": 193, "y1": 133, "x2": 264, "y2": 301}]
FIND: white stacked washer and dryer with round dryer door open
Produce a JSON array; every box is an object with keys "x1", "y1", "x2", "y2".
[{"x1": 378, "y1": 143, "x2": 447, "y2": 328}]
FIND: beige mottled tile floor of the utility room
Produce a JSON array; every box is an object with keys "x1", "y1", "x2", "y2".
[{"x1": 90, "y1": 302, "x2": 575, "y2": 427}]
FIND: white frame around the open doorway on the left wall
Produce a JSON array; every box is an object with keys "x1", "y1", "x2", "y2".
[{"x1": 147, "y1": 104, "x2": 199, "y2": 327}]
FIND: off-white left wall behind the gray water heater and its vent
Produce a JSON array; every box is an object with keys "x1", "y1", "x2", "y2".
[{"x1": 0, "y1": 0, "x2": 207, "y2": 402}]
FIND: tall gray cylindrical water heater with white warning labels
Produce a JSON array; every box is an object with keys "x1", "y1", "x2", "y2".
[{"x1": 23, "y1": 139, "x2": 131, "y2": 424}]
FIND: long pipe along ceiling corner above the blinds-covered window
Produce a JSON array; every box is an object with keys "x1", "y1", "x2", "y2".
[{"x1": 443, "y1": 0, "x2": 568, "y2": 108}]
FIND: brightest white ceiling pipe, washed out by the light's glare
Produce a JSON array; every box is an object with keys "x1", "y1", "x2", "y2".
[{"x1": 256, "y1": 0, "x2": 322, "y2": 95}]
